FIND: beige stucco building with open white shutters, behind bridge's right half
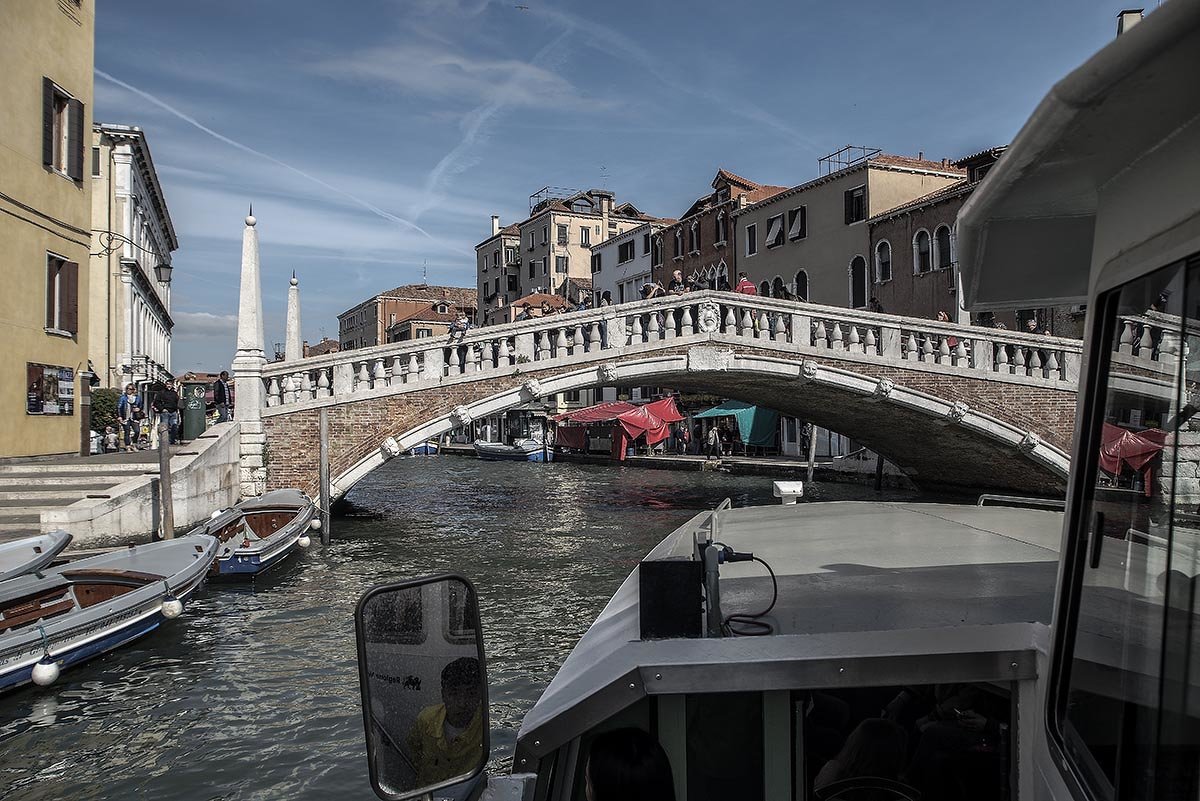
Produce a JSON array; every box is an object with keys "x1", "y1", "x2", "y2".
[{"x1": 733, "y1": 149, "x2": 966, "y2": 308}]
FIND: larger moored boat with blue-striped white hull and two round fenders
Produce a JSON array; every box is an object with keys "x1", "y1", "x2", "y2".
[{"x1": 0, "y1": 536, "x2": 217, "y2": 692}]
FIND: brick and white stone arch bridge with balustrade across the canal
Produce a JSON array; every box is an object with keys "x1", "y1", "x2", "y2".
[{"x1": 242, "y1": 291, "x2": 1152, "y2": 499}]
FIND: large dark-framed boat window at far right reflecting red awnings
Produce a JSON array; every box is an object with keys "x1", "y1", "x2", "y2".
[{"x1": 1050, "y1": 257, "x2": 1200, "y2": 799}]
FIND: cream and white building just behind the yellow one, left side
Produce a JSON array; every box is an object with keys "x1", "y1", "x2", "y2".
[{"x1": 88, "y1": 124, "x2": 179, "y2": 387}]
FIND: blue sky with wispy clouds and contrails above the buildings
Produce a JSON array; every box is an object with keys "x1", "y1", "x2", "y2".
[{"x1": 95, "y1": 0, "x2": 1122, "y2": 373}]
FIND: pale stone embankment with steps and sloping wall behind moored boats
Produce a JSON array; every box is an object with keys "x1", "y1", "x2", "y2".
[{"x1": 0, "y1": 422, "x2": 239, "y2": 547}]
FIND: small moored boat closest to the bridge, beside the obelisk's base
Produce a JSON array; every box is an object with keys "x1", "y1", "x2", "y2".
[{"x1": 192, "y1": 489, "x2": 318, "y2": 578}]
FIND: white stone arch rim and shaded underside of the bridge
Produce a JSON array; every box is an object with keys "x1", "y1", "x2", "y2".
[{"x1": 321, "y1": 345, "x2": 1069, "y2": 499}]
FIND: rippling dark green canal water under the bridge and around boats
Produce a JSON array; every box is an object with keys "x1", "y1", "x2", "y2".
[{"x1": 0, "y1": 457, "x2": 912, "y2": 801}]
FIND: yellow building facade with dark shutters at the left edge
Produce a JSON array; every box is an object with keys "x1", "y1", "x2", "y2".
[{"x1": 0, "y1": 0, "x2": 95, "y2": 457}]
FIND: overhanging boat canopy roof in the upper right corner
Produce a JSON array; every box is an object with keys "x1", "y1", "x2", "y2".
[{"x1": 958, "y1": 2, "x2": 1200, "y2": 309}]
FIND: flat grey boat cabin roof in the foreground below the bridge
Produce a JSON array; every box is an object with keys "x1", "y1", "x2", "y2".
[{"x1": 518, "y1": 502, "x2": 1062, "y2": 757}]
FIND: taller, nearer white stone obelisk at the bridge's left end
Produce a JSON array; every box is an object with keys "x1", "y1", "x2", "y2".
[{"x1": 233, "y1": 210, "x2": 266, "y2": 498}]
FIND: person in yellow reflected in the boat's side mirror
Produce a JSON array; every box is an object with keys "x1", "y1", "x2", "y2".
[{"x1": 408, "y1": 656, "x2": 484, "y2": 787}]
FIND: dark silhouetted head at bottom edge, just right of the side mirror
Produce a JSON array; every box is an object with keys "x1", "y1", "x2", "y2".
[{"x1": 583, "y1": 729, "x2": 676, "y2": 801}]
